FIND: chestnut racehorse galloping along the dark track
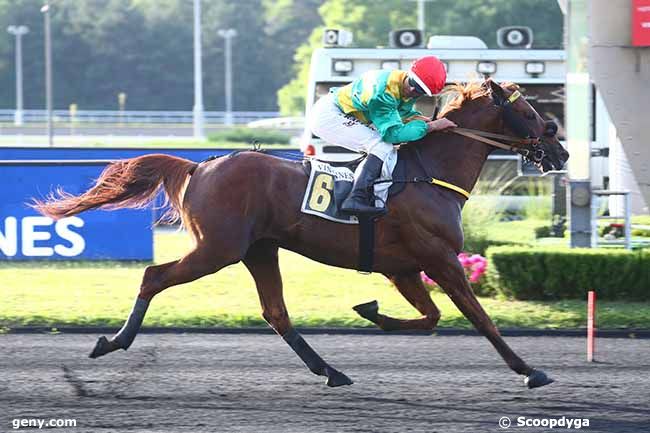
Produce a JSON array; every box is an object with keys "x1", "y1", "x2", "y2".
[{"x1": 34, "y1": 80, "x2": 568, "y2": 388}]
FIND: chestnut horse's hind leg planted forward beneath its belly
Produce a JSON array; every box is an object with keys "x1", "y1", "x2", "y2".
[{"x1": 244, "y1": 240, "x2": 352, "y2": 386}]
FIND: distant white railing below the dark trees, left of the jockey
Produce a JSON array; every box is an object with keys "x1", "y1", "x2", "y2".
[{"x1": 0, "y1": 110, "x2": 280, "y2": 124}]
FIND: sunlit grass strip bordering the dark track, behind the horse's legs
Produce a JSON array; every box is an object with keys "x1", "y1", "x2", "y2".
[{"x1": 0, "y1": 232, "x2": 650, "y2": 329}]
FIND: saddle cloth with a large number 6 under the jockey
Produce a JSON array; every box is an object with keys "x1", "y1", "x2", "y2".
[{"x1": 300, "y1": 149, "x2": 398, "y2": 224}]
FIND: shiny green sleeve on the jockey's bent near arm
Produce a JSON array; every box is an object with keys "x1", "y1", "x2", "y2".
[{"x1": 368, "y1": 94, "x2": 427, "y2": 143}]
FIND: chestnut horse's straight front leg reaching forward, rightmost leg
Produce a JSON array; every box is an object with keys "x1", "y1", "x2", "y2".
[{"x1": 424, "y1": 248, "x2": 553, "y2": 388}]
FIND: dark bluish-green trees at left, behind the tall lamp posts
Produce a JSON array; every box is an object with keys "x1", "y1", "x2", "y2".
[{"x1": 0, "y1": 0, "x2": 322, "y2": 111}]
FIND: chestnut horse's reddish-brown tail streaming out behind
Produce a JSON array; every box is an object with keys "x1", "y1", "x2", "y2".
[{"x1": 32, "y1": 154, "x2": 198, "y2": 222}]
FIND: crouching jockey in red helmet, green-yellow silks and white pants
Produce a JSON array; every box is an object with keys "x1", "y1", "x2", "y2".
[{"x1": 309, "y1": 56, "x2": 456, "y2": 215}]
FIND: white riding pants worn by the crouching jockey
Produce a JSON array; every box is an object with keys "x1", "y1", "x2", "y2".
[{"x1": 309, "y1": 93, "x2": 393, "y2": 161}]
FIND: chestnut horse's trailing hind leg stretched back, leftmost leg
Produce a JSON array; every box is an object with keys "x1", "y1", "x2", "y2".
[{"x1": 89, "y1": 248, "x2": 239, "y2": 358}]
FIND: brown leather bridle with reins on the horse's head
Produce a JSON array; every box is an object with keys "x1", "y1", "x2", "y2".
[{"x1": 449, "y1": 90, "x2": 557, "y2": 164}]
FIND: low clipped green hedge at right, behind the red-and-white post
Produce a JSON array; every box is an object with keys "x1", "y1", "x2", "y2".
[{"x1": 486, "y1": 247, "x2": 650, "y2": 301}]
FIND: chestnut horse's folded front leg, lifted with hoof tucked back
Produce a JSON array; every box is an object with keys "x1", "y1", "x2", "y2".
[{"x1": 353, "y1": 272, "x2": 440, "y2": 331}]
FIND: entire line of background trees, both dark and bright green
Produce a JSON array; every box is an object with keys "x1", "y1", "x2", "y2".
[{"x1": 0, "y1": 0, "x2": 562, "y2": 114}]
